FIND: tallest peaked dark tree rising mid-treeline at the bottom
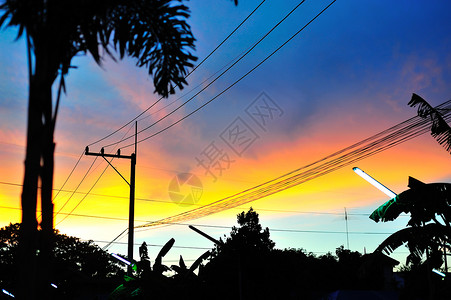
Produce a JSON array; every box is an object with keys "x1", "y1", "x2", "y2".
[{"x1": 204, "y1": 208, "x2": 275, "y2": 299}]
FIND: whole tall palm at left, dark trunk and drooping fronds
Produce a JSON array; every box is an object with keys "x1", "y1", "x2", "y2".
[{"x1": 0, "y1": 0, "x2": 196, "y2": 299}]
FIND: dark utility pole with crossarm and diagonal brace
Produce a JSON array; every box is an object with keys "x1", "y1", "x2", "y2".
[{"x1": 85, "y1": 122, "x2": 138, "y2": 275}]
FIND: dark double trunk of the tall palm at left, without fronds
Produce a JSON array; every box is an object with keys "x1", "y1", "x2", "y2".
[{"x1": 17, "y1": 39, "x2": 57, "y2": 299}]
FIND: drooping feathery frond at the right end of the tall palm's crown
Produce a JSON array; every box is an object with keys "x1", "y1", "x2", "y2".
[{"x1": 110, "y1": 0, "x2": 197, "y2": 96}]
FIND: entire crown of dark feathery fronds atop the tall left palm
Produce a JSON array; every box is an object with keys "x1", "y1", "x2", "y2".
[{"x1": 0, "y1": 0, "x2": 197, "y2": 97}]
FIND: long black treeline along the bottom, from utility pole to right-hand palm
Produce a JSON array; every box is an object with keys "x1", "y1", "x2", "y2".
[{"x1": 110, "y1": 209, "x2": 416, "y2": 300}]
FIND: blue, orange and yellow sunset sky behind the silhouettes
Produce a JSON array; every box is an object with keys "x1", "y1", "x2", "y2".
[{"x1": 0, "y1": 0, "x2": 451, "y2": 265}]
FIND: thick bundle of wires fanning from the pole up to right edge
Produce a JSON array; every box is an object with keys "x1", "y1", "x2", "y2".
[{"x1": 135, "y1": 100, "x2": 451, "y2": 228}]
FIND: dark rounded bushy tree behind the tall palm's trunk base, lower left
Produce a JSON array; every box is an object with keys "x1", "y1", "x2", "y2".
[{"x1": 0, "y1": 223, "x2": 125, "y2": 299}]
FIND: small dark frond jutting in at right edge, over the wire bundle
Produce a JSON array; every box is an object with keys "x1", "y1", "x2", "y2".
[{"x1": 408, "y1": 94, "x2": 451, "y2": 154}]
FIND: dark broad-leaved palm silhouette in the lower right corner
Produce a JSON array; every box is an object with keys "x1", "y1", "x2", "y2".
[{"x1": 370, "y1": 177, "x2": 451, "y2": 299}]
